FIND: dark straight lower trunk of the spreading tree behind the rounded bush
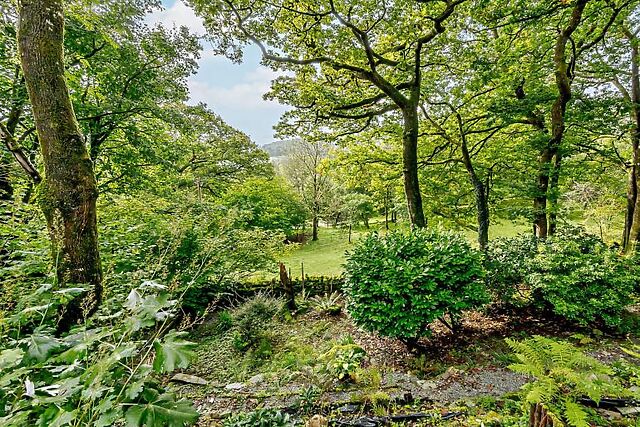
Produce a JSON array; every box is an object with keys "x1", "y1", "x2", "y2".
[{"x1": 402, "y1": 107, "x2": 427, "y2": 227}]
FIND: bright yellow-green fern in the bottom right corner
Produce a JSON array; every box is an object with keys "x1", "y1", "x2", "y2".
[{"x1": 505, "y1": 336, "x2": 628, "y2": 427}]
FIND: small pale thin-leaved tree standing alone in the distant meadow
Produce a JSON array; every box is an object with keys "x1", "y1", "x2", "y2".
[{"x1": 283, "y1": 139, "x2": 332, "y2": 241}]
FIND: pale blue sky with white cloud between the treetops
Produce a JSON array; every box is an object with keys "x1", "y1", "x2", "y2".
[{"x1": 147, "y1": 0, "x2": 287, "y2": 145}]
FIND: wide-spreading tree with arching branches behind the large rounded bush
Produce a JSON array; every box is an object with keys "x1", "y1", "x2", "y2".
[{"x1": 190, "y1": 0, "x2": 476, "y2": 227}]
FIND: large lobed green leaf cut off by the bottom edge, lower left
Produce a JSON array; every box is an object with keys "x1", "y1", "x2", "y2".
[{"x1": 125, "y1": 393, "x2": 199, "y2": 427}]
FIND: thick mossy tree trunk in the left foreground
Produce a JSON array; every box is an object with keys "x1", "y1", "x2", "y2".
[{"x1": 18, "y1": 0, "x2": 102, "y2": 332}]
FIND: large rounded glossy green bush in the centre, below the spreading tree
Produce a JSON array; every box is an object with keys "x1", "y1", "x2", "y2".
[{"x1": 345, "y1": 230, "x2": 487, "y2": 341}]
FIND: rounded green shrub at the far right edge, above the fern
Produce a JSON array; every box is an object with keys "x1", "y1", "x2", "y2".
[{"x1": 527, "y1": 233, "x2": 637, "y2": 328}]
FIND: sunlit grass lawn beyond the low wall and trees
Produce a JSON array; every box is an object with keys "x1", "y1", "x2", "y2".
[{"x1": 265, "y1": 219, "x2": 530, "y2": 277}]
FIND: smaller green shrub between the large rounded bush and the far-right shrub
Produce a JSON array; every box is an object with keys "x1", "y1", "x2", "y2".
[{"x1": 485, "y1": 235, "x2": 537, "y2": 306}]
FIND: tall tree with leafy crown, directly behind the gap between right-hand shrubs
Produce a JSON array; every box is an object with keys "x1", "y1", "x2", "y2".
[{"x1": 499, "y1": 0, "x2": 634, "y2": 238}]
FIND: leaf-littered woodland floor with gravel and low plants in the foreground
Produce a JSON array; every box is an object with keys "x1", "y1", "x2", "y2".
[{"x1": 169, "y1": 310, "x2": 636, "y2": 426}]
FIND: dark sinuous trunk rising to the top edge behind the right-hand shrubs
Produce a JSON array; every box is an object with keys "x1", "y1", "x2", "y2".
[{"x1": 533, "y1": 0, "x2": 589, "y2": 239}]
